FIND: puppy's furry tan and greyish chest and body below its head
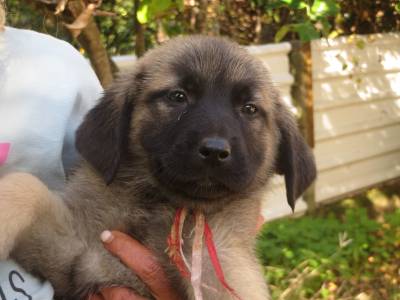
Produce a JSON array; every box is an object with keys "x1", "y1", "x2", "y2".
[{"x1": 13, "y1": 169, "x2": 266, "y2": 299}]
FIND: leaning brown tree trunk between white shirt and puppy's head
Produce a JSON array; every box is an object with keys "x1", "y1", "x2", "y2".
[{"x1": 67, "y1": 1, "x2": 113, "y2": 87}]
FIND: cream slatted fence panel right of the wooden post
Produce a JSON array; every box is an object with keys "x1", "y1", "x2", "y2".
[{"x1": 311, "y1": 33, "x2": 400, "y2": 202}]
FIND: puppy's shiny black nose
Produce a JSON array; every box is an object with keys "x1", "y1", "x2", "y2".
[{"x1": 199, "y1": 137, "x2": 231, "y2": 163}]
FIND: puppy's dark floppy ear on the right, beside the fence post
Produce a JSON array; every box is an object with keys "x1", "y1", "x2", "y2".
[{"x1": 276, "y1": 103, "x2": 317, "y2": 210}]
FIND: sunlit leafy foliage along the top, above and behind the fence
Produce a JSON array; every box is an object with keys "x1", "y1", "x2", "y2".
[{"x1": 6, "y1": 0, "x2": 400, "y2": 55}]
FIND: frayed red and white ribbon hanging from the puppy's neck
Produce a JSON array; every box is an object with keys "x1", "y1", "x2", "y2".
[{"x1": 167, "y1": 208, "x2": 241, "y2": 300}]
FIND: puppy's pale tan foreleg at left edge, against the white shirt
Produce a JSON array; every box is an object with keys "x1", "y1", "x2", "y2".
[{"x1": 0, "y1": 173, "x2": 51, "y2": 260}]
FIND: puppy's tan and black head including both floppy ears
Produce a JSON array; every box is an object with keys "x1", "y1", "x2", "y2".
[{"x1": 77, "y1": 36, "x2": 316, "y2": 207}]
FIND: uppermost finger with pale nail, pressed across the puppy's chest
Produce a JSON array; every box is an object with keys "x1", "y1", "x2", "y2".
[{"x1": 101, "y1": 231, "x2": 179, "y2": 300}]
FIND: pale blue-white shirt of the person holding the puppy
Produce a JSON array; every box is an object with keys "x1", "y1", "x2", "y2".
[{"x1": 0, "y1": 27, "x2": 102, "y2": 300}]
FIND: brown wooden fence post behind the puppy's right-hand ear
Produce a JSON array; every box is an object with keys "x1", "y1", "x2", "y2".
[{"x1": 289, "y1": 41, "x2": 316, "y2": 212}]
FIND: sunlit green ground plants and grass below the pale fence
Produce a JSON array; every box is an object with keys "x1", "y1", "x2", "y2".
[{"x1": 257, "y1": 184, "x2": 400, "y2": 300}]
